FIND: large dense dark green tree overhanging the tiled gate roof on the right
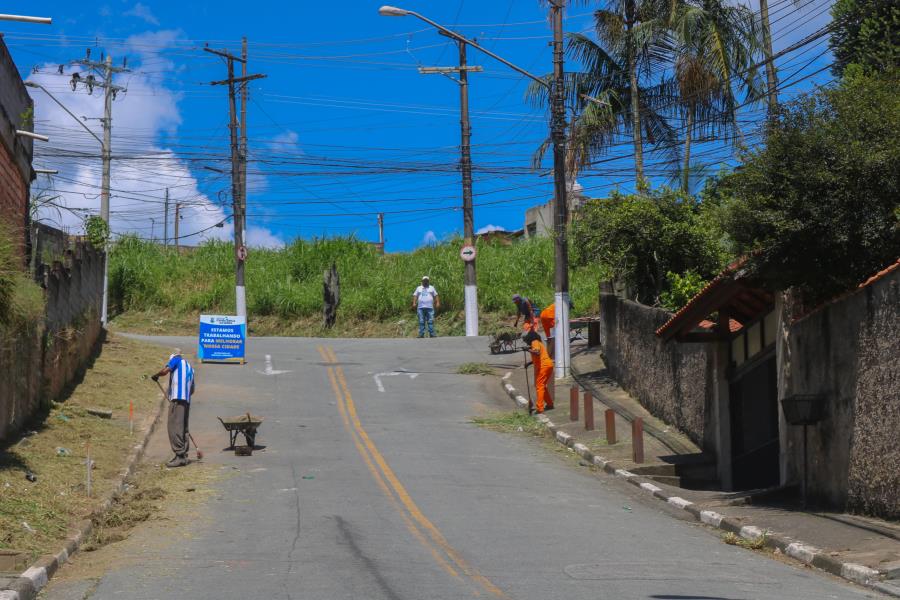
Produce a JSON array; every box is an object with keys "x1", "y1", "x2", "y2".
[{"x1": 716, "y1": 67, "x2": 900, "y2": 302}]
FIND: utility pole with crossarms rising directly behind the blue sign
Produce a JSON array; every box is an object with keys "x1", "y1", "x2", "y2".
[{"x1": 204, "y1": 38, "x2": 265, "y2": 317}]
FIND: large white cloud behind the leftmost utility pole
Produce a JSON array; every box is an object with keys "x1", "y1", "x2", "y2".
[{"x1": 29, "y1": 31, "x2": 283, "y2": 247}]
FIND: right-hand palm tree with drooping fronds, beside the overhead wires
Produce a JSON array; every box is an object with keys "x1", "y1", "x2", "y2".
[{"x1": 670, "y1": 0, "x2": 761, "y2": 191}]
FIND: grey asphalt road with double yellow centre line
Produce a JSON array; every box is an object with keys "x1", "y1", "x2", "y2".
[{"x1": 37, "y1": 338, "x2": 878, "y2": 600}]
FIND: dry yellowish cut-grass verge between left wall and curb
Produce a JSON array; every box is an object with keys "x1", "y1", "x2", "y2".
[{"x1": 0, "y1": 336, "x2": 166, "y2": 558}]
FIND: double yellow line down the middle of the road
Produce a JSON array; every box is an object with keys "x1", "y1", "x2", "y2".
[{"x1": 326, "y1": 348, "x2": 507, "y2": 598}]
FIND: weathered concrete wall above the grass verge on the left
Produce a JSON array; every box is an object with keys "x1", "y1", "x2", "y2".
[{"x1": 0, "y1": 225, "x2": 103, "y2": 440}]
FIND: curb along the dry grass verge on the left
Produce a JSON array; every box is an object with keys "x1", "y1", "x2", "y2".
[{"x1": 0, "y1": 398, "x2": 166, "y2": 600}]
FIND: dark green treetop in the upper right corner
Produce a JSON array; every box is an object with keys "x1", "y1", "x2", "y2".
[{"x1": 830, "y1": 0, "x2": 900, "y2": 75}]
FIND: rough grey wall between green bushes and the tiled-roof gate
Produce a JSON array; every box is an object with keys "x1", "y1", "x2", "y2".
[{"x1": 600, "y1": 293, "x2": 715, "y2": 451}]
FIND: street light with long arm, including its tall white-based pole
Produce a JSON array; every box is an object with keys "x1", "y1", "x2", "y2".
[{"x1": 378, "y1": 0, "x2": 570, "y2": 379}]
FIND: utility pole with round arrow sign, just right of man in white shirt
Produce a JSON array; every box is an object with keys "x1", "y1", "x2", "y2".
[{"x1": 419, "y1": 32, "x2": 484, "y2": 337}]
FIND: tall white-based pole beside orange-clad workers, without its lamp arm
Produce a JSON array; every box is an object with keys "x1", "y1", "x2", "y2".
[{"x1": 550, "y1": 0, "x2": 570, "y2": 379}]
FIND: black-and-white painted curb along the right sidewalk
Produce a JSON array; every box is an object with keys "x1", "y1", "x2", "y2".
[{"x1": 501, "y1": 377, "x2": 900, "y2": 598}]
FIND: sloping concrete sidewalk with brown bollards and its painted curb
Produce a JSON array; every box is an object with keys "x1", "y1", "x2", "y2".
[{"x1": 503, "y1": 346, "x2": 900, "y2": 597}]
